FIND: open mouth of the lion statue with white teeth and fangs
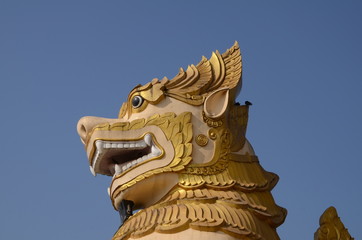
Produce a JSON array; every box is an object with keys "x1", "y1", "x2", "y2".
[{"x1": 90, "y1": 133, "x2": 162, "y2": 177}]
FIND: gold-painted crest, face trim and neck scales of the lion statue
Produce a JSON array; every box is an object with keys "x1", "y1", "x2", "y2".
[{"x1": 78, "y1": 43, "x2": 286, "y2": 240}]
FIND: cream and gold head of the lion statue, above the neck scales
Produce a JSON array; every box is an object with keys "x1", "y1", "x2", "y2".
[{"x1": 77, "y1": 43, "x2": 254, "y2": 209}]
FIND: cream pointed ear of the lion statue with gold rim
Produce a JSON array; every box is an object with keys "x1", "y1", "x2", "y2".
[{"x1": 204, "y1": 88, "x2": 229, "y2": 118}]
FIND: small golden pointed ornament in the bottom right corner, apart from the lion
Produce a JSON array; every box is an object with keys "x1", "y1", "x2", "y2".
[{"x1": 314, "y1": 207, "x2": 354, "y2": 240}]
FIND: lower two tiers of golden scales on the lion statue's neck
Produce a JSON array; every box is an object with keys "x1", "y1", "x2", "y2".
[{"x1": 113, "y1": 185, "x2": 285, "y2": 240}]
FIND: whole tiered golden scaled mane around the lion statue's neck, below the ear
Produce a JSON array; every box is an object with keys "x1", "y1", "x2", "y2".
[{"x1": 113, "y1": 122, "x2": 286, "y2": 240}]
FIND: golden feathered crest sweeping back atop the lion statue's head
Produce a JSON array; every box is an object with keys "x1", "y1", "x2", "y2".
[{"x1": 165, "y1": 42, "x2": 242, "y2": 106}]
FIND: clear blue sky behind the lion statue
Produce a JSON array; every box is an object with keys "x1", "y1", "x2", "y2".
[{"x1": 0, "y1": 0, "x2": 362, "y2": 240}]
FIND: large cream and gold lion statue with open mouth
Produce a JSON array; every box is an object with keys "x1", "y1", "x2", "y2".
[{"x1": 77, "y1": 42, "x2": 354, "y2": 240}]
